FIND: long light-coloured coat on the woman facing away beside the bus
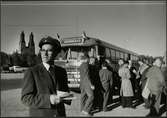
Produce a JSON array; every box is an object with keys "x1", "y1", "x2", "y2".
[{"x1": 118, "y1": 65, "x2": 134, "y2": 97}]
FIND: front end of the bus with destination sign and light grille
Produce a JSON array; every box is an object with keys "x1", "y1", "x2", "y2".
[{"x1": 55, "y1": 37, "x2": 95, "y2": 88}]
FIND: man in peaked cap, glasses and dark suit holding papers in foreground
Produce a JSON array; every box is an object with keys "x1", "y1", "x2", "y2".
[{"x1": 21, "y1": 37, "x2": 70, "y2": 117}]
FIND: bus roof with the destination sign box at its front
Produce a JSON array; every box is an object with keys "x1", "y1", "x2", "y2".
[{"x1": 61, "y1": 36, "x2": 138, "y2": 55}]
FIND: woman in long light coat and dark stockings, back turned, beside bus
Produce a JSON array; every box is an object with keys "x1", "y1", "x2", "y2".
[{"x1": 118, "y1": 61, "x2": 134, "y2": 108}]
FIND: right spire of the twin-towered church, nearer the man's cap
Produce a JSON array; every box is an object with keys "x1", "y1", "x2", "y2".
[{"x1": 28, "y1": 32, "x2": 35, "y2": 55}]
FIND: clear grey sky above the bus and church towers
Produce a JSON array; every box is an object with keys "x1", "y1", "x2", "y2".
[{"x1": 1, "y1": 1, "x2": 166, "y2": 56}]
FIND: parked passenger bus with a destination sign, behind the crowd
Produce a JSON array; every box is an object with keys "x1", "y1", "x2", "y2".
[{"x1": 54, "y1": 33, "x2": 138, "y2": 91}]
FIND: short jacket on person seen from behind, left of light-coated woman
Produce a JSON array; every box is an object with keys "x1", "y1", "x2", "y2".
[{"x1": 99, "y1": 69, "x2": 113, "y2": 91}]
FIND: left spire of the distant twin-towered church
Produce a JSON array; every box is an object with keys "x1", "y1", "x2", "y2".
[{"x1": 19, "y1": 31, "x2": 26, "y2": 54}]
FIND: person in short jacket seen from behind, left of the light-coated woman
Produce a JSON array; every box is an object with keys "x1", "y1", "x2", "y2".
[{"x1": 99, "y1": 61, "x2": 113, "y2": 111}]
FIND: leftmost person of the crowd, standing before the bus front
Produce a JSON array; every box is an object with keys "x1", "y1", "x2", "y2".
[{"x1": 80, "y1": 54, "x2": 95, "y2": 116}]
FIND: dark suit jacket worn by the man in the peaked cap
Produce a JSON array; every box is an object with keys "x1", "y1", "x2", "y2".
[{"x1": 21, "y1": 64, "x2": 69, "y2": 117}]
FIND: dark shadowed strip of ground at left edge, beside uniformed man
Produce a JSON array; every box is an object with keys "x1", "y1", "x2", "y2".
[{"x1": 1, "y1": 79, "x2": 22, "y2": 91}]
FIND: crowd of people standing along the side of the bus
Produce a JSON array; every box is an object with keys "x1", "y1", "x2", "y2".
[{"x1": 80, "y1": 55, "x2": 167, "y2": 116}]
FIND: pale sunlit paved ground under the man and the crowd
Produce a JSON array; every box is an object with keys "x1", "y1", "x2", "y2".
[{"x1": 1, "y1": 74, "x2": 166, "y2": 117}]
